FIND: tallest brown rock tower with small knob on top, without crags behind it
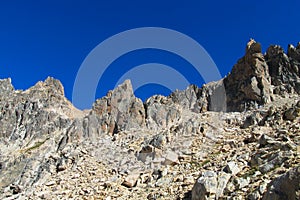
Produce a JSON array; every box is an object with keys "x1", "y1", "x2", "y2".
[{"x1": 224, "y1": 39, "x2": 272, "y2": 111}]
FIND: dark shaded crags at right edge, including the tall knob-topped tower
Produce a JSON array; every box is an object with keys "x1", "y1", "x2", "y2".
[{"x1": 224, "y1": 39, "x2": 300, "y2": 111}]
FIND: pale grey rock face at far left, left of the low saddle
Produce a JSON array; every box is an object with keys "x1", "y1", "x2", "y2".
[{"x1": 0, "y1": 78, "x2": 80, "y2": 187}]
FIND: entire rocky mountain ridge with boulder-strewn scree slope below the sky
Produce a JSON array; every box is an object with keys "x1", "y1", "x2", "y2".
[{"x1": 0, "y1": 39, "x2": 300, "y2": 200}]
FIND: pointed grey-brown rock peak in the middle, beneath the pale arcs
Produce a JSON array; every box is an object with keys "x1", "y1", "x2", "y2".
[{"x1": 92, "y1": 80, "x2": 145, "y2": 134}]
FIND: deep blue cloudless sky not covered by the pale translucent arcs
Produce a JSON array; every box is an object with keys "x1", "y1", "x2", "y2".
[{"x1": 0, "y1": 0, "x2": 300, "y2": 107}]
